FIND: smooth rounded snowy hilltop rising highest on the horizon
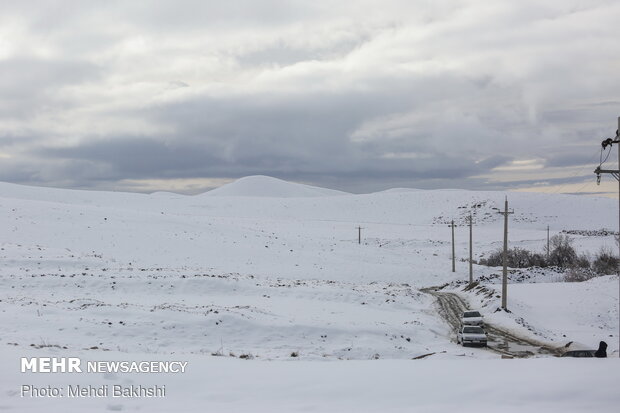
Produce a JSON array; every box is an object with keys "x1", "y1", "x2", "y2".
[{"x1": 204, "y1": 175, "x2": 347, "y2": 198}]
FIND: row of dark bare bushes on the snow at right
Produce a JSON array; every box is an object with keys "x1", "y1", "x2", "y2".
[{"x1": 478, "y1": 234, "x2": 618, "y2": 281}]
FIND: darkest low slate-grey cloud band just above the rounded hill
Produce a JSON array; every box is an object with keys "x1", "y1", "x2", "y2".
[{"x1": 38, "y1": 138, "x2": 505, "y2": 190}]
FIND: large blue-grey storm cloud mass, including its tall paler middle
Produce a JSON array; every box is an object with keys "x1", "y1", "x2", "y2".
[{"x1": 33, "y1": 73, "x2": 511, "y2": 189}]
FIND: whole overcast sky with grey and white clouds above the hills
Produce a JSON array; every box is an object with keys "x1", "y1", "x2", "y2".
[{"x1": 0, "y1": 0, "x2": 620, "y2": 193}]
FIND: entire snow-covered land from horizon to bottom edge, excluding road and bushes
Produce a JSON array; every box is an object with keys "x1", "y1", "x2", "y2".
[{"x1": 0, "y1": 177, "x2": 620, "y2": 411}]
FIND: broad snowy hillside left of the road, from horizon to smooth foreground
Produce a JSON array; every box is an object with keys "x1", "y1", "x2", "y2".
[{"x1": 0, "y1": 177, "x2": 617, "y2": 359}]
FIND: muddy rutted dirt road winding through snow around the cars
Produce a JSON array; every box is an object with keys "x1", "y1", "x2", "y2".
[{"x1": 421, "y1": 288, "x2": 563, "y2": 358}]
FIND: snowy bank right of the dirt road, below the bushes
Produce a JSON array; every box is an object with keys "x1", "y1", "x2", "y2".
[{"x1": 454, "y1": 276, "x2": 618, "y2": 350}]
